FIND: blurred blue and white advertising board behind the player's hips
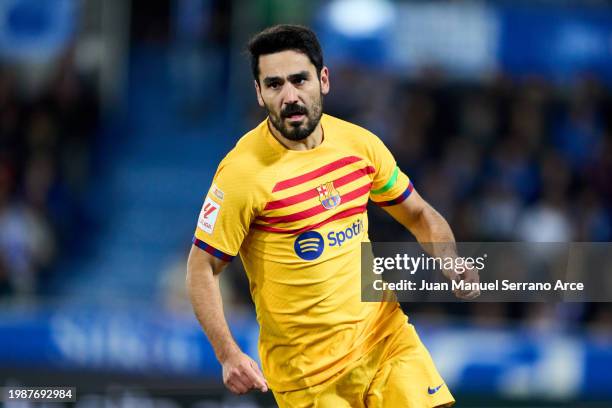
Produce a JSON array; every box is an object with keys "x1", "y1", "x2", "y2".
[{"x1": 0, "y1": 309, "x2": 612, "y2": 399}]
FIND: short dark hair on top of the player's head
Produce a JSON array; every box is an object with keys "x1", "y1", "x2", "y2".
[{"x1": 248, "y1": 24, "x2": 323, "y2": 82}]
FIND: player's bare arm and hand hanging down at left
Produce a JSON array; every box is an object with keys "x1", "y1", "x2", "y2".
[{"x1": 187, "y1": 246, "x2": 268, "y2": 394}]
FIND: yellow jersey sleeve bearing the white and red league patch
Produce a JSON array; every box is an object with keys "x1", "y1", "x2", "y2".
[{"x1": 193, "y1": 163, "x2": 254, "y2": 262}]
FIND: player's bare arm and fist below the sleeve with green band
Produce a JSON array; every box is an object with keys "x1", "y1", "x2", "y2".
[{"x1": 384, "y1": 191, "x2": 480, "y2": 299}]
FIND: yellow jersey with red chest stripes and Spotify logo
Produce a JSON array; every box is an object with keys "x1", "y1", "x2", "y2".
[{"x1": 193, "y1": 115, "x2": 413, "y2": 391}]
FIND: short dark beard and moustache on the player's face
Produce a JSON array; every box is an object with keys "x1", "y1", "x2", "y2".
[{"x1": 266, "y1": 94, "x2": 323, "y2": 141}]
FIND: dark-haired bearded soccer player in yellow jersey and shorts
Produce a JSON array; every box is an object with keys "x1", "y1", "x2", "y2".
[{"x1": 187, "y1": 25, "x2": 478, "y2": 408}]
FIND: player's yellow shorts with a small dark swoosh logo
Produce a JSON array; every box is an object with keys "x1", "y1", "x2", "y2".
[{"x1": 274, "y1": 323, "x2": 455, "y2": 408}]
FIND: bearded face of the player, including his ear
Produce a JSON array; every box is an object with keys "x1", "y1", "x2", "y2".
[{"x1": 255, "y1": 50, "x2": 329, "y2": 141}]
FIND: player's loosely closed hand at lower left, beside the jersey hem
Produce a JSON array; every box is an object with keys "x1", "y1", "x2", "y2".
[{"x1": 222, "y1": 350, "x2": 268, "y2": 394}]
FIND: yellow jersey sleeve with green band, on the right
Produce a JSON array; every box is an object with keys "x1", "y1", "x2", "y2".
[{"x1": 370, "y1": 135, "x2": 413, "y2": 207}]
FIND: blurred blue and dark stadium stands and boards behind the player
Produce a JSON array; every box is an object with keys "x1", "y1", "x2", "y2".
[{"x1": 0, "y1": 0, "x2": 612, "y2": 407}]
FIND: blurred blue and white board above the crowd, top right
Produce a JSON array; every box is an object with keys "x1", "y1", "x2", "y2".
[{"x1": 317, "y1": 0, "x2": 612, "y2": 81}]
